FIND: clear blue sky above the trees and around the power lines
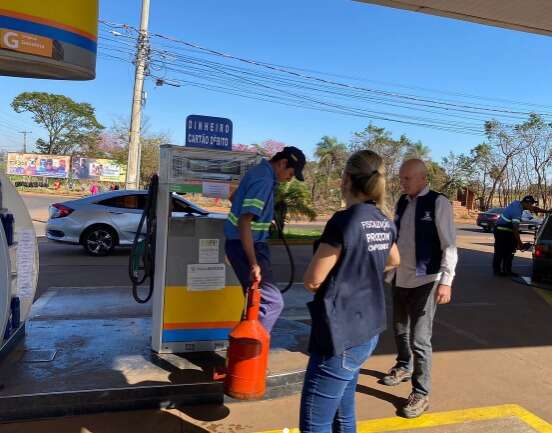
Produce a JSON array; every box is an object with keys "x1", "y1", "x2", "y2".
[{"x1": 0, "y1": 0, "x2": 552, "y2": 160}]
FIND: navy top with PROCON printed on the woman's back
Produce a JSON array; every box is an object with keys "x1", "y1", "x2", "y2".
[{"x1": 308, "y1": 202, "x2": 397, "y2": 355}]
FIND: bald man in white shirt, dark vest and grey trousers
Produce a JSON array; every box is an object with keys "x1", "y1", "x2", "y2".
[{"x1": 382, "y1": 159, "x2": 458, "y2": 418}]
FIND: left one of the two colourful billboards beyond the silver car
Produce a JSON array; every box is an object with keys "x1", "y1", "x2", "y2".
[{"x1": 6, "y1": 153, "x2": 71, "y2": 179}]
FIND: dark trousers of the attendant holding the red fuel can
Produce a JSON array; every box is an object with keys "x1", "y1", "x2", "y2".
[{"x1": 225, "y1": 239, "x2": 284, "y2": 332}]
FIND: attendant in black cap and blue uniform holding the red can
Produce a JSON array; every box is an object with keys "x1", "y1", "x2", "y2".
[{"x1": 224, "y1": 146, "x2": 306, "y2": 332}]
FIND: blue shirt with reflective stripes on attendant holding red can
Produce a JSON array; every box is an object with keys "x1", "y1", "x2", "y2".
[{"x1": 224, "y1": 160, "x2": 277, "y2": 242}]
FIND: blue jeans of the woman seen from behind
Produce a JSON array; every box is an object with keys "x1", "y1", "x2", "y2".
[{"x1": 299, "y1": 335, "x2": 379, "y2": 433}]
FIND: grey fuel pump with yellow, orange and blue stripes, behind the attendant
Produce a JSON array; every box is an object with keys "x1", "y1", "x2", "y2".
[{"x1": 151, "y1": 145, "x2": 260, "y2": 353}]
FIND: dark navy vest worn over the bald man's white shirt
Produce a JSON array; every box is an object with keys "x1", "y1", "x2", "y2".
[{"x1": 395, "y1": 191, "x2": 443, "y2": 275}]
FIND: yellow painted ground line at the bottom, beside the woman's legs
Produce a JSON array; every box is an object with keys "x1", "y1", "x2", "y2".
[{"x1": 264, "y1": 404, "x2": 552, "y2": 433}]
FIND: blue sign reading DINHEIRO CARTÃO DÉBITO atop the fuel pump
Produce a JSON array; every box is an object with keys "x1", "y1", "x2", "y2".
[{"x1": 186, "y1": 114, "x2": 232, "y2": 150}]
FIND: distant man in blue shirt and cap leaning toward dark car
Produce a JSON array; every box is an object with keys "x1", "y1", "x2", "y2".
[{"x1": 493, "y1": 195, "x2": 550, "y2": 276}]
